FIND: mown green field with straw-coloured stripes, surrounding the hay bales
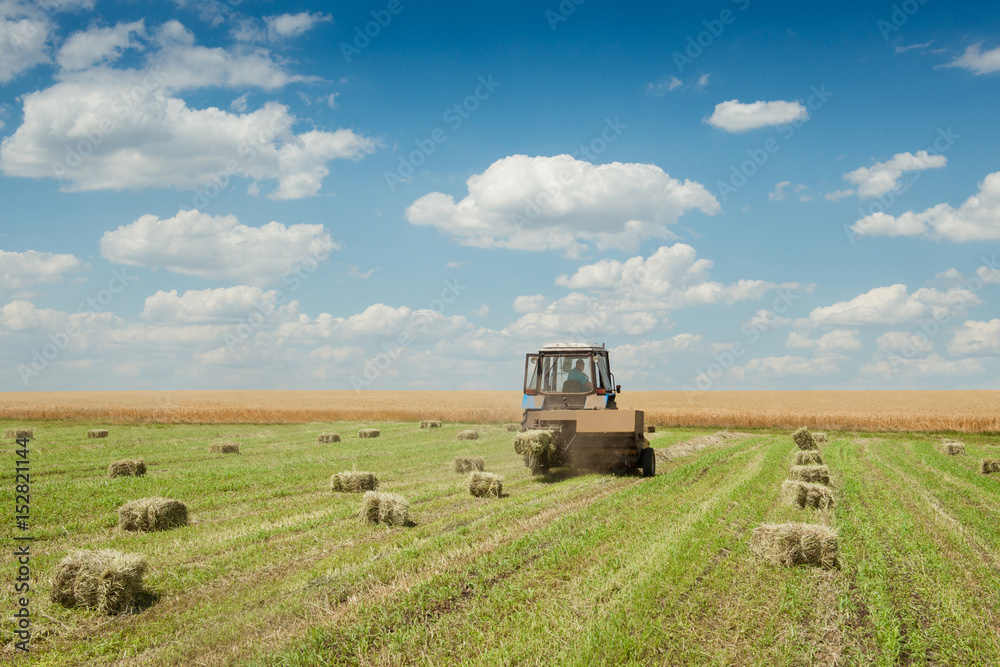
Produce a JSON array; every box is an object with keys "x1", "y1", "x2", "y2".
[{"x1": 0, "y1": 422, "x2": 1000, "y2": 665}]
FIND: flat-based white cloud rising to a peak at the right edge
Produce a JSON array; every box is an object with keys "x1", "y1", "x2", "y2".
[{"x1": 851, "y1": 172, "x2": 1000, "y2": 243}]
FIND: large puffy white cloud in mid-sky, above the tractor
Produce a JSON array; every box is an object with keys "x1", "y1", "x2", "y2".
[{"x1": 406, "y1": 155, "x2": 720, "y2": 256}]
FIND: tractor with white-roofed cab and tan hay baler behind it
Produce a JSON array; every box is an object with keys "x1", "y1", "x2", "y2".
[{"x1": 521, "y1": 343, "x2": 656, "y2": 477}]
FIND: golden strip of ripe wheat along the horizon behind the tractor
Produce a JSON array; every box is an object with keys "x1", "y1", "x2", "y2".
[{"x1": 0, "y1": 390, "x2": 1000, "y2": 432}]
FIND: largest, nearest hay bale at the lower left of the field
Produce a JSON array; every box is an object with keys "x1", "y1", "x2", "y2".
[{"x1": 50, "y1": 549, "x2": 146, "y2": 614}]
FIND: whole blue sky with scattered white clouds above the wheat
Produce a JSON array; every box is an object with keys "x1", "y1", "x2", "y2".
[{"x1": 0, "y1": 0, "x2": 1000, "y2": 391}]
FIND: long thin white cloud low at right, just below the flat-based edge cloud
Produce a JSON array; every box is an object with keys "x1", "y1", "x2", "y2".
[{"x1": 809, "y1": 284, "x2": 982, "y2": 326}]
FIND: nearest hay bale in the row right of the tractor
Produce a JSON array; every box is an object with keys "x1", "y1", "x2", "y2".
[{"x1": 750, "y1": 523, "x2": 837, "y2": 569}]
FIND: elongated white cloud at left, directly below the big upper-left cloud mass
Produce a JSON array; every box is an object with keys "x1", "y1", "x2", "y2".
[{"x1": 100, "y1": 210, "x2": 340, "y2": 285}]
